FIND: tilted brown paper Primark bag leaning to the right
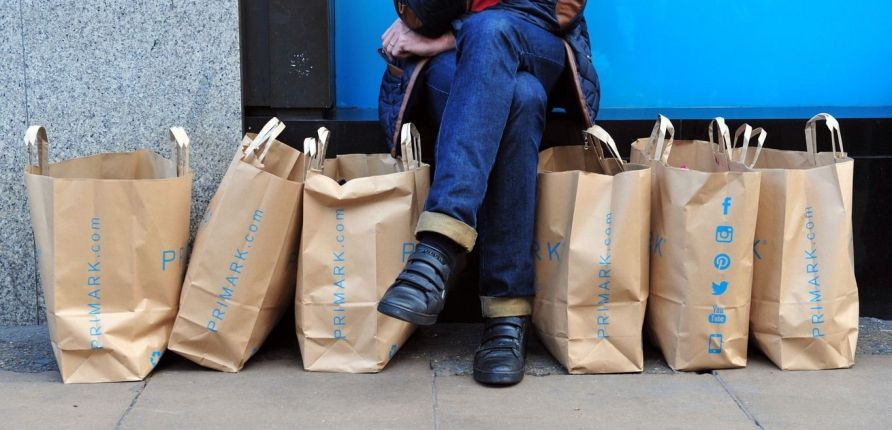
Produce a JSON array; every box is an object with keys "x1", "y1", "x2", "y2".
[{"x1": 170, "y1": 118, "x2": 307, "y2": 372}]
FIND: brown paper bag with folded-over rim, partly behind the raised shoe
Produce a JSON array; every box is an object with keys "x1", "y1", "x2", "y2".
[{"x1": 295, "y1": 124, "x2": 430, "y2": 373}]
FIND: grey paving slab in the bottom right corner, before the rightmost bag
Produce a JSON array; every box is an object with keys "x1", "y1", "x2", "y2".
[{"x1": 716, "y1": 355, "x2": 892, "y2": 430}]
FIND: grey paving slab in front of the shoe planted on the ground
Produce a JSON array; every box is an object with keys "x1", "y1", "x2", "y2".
[{"x1": 435, "y1": 373, "x2": 755, "y2": 430}]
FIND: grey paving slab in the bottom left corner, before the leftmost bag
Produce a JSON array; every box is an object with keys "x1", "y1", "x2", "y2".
[{"x1": 0, "y1": 370, "x2": 143, "y2": 429}]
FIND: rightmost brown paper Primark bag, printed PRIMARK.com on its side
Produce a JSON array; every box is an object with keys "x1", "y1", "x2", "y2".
[{"x1": 741, "y1": 114, "x2": 858, "y2": 370}]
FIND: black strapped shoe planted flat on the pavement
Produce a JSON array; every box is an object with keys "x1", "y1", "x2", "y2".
[{"x1": 474, "y1": 316, "x2": 530, "y2": 385}]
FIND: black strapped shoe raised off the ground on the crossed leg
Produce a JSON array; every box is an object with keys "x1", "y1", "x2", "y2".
[{"x1": 378, "y1": 242, "x2": 456, "y2": 325}]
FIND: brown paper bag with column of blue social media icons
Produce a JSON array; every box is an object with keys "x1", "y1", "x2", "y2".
[{"x1": 632, "y1": 115, "x2": 759, "y2": 370}]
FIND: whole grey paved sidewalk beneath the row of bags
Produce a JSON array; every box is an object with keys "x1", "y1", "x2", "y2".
[{"x1": 0, "y1": 318, "x2": 892, "y2": 430}]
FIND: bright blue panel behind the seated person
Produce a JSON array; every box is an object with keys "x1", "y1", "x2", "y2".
[{"x1": 335, "y1": 0, "x2": 892, "y2": 118}]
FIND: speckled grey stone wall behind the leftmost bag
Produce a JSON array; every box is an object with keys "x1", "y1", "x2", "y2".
[{"x1": 0, "y1": 0, "x2": 241, "y2": 325}]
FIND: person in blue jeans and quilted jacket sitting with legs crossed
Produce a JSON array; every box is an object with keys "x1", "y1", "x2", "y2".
[{"x1": 378, "y1": 0, "x2": 600, "y2": 385}]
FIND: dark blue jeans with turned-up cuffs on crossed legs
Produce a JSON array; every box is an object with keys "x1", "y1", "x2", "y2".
[{"x1": 418, "y1": 8, "x2": 566, "y2": 306}]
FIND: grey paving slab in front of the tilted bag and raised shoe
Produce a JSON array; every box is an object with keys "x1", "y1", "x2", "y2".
[{"x1": 121, "y1": 352, "x2": 433, "y2": 429}]
